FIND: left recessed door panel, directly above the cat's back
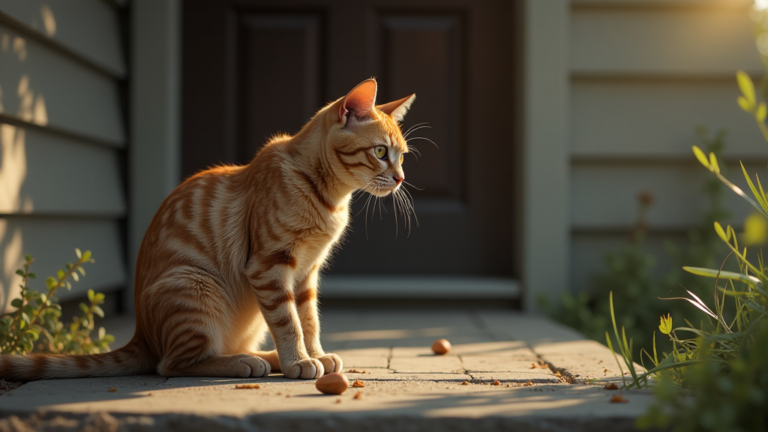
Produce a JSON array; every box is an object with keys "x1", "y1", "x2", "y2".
[{"x1": 237, "y1": 13, "x2": 323, "y2": 163}]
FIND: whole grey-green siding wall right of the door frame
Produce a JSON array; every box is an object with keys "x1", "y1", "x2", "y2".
[{"x1": 568, "y1": 0, "x2": 768, "y2": 291}]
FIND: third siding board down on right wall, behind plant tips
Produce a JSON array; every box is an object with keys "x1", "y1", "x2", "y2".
[{"x1": 571, "y1": 162, "x2": 768, "y2": 232}]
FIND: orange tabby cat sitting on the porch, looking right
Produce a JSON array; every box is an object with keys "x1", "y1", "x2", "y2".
[{"x1": 0, "y1": 79, "x2": 415, "y2": 380}]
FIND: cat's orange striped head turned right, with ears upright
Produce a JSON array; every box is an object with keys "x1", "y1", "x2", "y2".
[{"x1": 327, "y1": 79, "x2": 416, "y2": 196}]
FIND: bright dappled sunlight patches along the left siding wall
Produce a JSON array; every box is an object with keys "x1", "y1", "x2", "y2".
[{"x1": 0, "y1": 5, "x2": 56, "y2": 313}]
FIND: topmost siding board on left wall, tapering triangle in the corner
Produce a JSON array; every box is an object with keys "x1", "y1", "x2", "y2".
[{"x1": 0, "y1": 0, "x2": 126, "y2": 78}]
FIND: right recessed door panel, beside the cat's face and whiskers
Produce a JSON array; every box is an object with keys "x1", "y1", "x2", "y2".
[{"x1": 380, "y1": 14, "x2": 467, "y2": 205}]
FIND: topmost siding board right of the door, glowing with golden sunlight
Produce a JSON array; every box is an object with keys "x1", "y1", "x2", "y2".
[{"x1": 570, "y1": 8, "x2": 763, "y2": 77}]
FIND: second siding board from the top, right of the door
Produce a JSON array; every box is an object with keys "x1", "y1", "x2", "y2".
[{"x1": 571, "y1": 78, "x2": 768, "y2": 159}]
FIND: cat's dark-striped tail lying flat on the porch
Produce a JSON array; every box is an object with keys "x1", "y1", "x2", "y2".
[{"x1": 0, "y1": 337, "x2": 157, "y2": 381}]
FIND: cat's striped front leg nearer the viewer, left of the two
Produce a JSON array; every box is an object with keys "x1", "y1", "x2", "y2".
[{"x1": 249, "y1": 266, "x2": 325, "y2": 379}]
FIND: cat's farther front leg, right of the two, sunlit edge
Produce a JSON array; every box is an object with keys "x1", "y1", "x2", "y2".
[{"x1": 296, "y1": 266, "x2": 344, "y2": 374}]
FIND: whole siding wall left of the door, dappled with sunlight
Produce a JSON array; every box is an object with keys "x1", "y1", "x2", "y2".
[{"x1": 0, "y1": 0, "x2": 127, "y2": 310}]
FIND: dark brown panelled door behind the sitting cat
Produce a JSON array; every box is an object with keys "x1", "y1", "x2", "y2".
[{"x1": 183, "y1": 0, "x2": 519, "y2": 277}]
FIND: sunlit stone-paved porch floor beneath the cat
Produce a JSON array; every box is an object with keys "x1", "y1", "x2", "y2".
[{"x1": 0, "y1": 310, "x2": 653, "y2": 432}]
